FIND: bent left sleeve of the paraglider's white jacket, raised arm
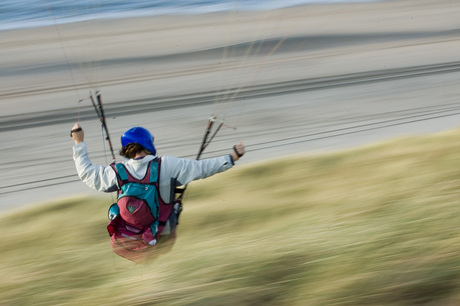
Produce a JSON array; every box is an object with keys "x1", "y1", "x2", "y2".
[{"x1": 73, "y1": 142, "x2": 118, "y2": 192}]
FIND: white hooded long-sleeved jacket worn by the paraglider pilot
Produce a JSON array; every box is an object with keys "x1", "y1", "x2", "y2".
[{"x1": 73, "y1": 142, "x2": 234, "y2": 203}]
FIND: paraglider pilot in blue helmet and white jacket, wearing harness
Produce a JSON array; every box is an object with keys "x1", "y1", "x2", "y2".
[{"x1": 71, "y1": 123, "x2": 245, "y2": 262}]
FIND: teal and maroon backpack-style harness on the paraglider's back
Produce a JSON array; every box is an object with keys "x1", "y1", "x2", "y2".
[{"x1": 107, "y1": 158, "x2": 181, "y2": 261}]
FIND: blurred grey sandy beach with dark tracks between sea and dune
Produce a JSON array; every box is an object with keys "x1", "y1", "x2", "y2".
[{"x1": 0, "y1": 0, "x2": 460, "y2": 209}]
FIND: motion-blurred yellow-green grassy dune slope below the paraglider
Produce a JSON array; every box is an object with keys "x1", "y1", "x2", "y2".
[{"x1": 0, "y1": 131, "x2": 460, "y2": 305}]
